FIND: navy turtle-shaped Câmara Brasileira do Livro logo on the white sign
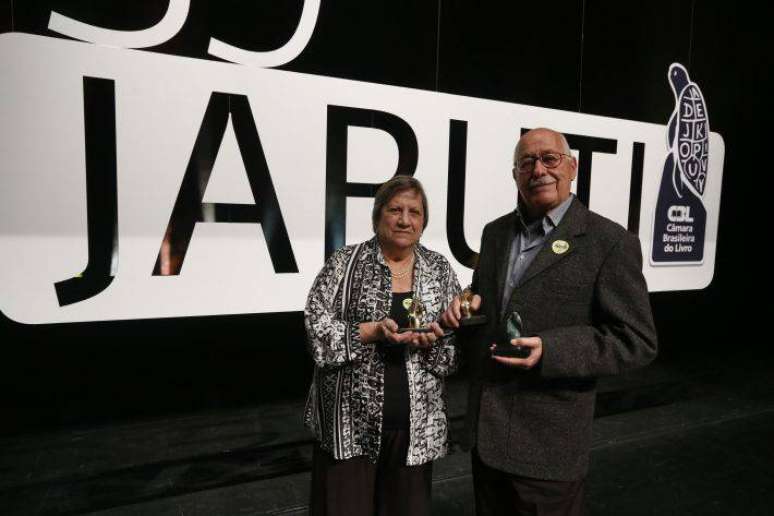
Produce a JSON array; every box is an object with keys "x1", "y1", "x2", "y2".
[{"x1": 651, "y1": 63, "x2": 710, "y2": 265}]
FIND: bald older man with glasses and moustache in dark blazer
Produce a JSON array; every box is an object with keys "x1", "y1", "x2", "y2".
[{"x1": 441, "y1": 129, "x2": 656, "y2": 515}]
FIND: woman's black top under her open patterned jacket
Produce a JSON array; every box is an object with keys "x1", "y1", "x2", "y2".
[{"x1": 380, "y1": 292, "x2": 414, "y2": 430}]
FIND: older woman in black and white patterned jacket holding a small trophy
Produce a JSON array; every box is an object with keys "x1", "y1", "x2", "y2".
[{"x1": 304, "y1": 176, "x2": 460, "y2": 516}]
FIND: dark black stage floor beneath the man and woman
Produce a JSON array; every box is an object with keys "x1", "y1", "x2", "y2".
[{"x1": 0, "y1": 346, "x2": 774, "y2": 516}]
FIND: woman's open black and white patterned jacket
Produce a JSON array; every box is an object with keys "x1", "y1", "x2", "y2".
[{"x1": 304, "y1": 237, "x2": 460, "y2": 466}]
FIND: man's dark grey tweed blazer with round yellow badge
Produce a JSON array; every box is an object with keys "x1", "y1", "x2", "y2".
[{"x1": 465, "y1": 199, "x2": 657, "y2": 480}]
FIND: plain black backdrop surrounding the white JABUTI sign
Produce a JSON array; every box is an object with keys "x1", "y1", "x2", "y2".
[{"x1": 0, "y1": 0, "x2": 774, "y2": 435}]
